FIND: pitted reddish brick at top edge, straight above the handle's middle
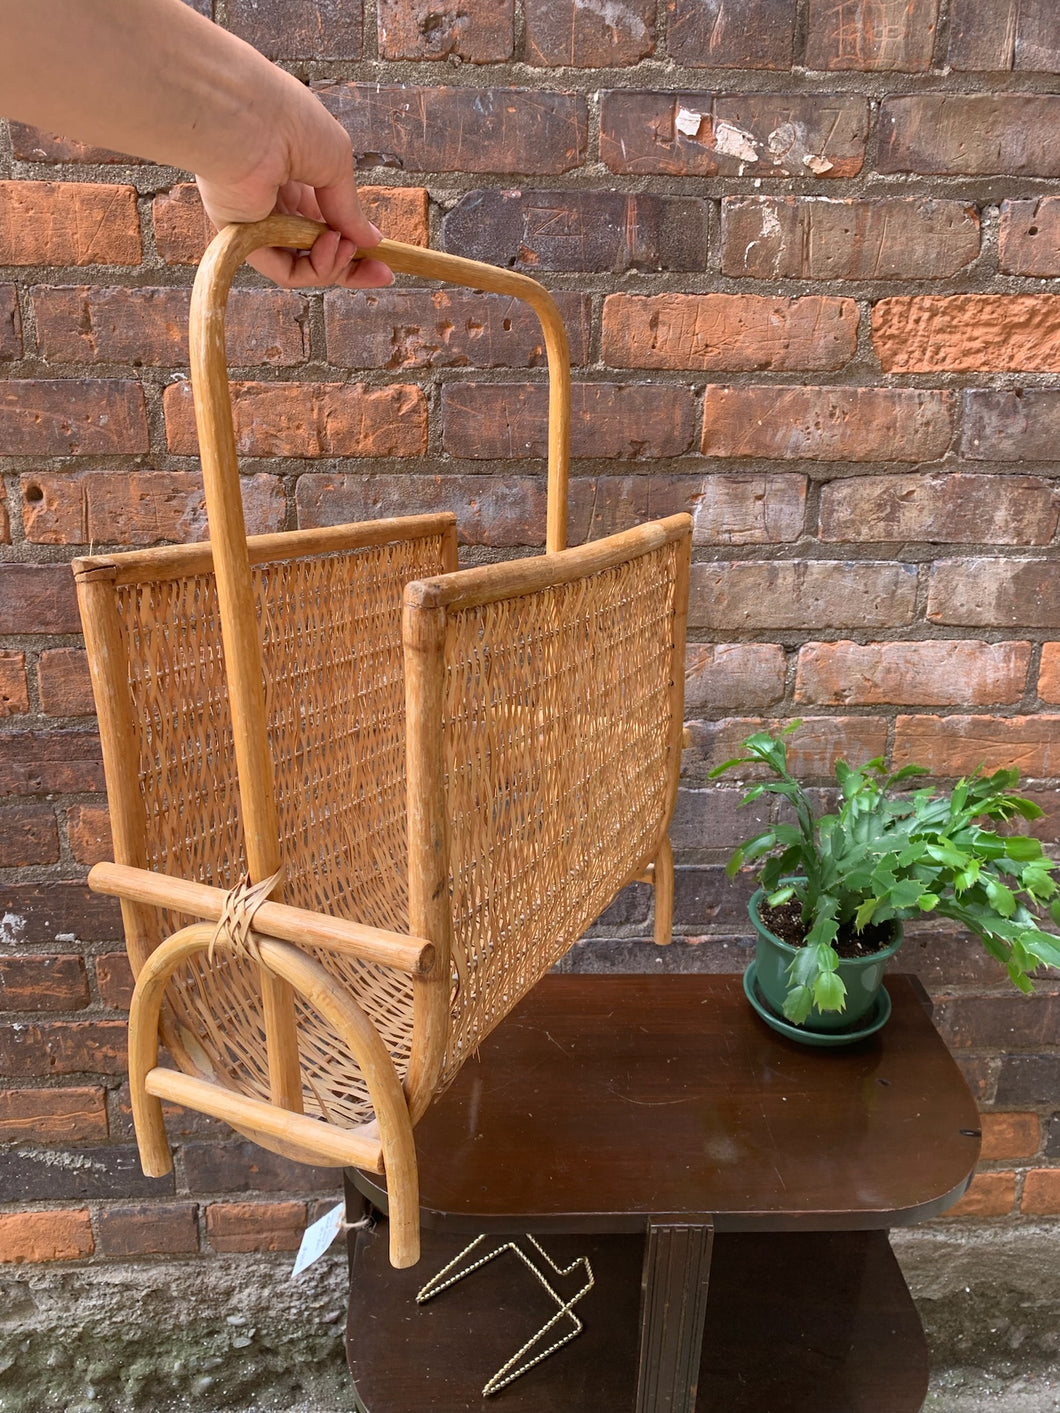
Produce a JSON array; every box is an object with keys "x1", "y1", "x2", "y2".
[{"x1": 377, "y1": 0, "x2": 514, "y2": 64}]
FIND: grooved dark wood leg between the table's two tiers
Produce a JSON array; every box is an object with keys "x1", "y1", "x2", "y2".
[{"x1": 635, "y1": 1219, "x2": 714, "y2": 1413}]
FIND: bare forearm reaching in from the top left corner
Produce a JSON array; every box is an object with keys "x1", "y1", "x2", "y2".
[{"x1": 0, "y1": 0, "x2": 297, "y2": 182}]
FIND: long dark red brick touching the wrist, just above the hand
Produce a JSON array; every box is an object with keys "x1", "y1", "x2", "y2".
[{"x1": 317, "y1": 83, "x2": 588, "y2": 177}]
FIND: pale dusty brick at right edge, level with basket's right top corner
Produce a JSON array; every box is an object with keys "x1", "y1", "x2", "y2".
[{"x1": 821, "y1": 472, "x2": 1060, "y2": 544}]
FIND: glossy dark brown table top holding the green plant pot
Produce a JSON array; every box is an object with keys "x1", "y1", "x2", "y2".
[{"x1": 358, "y1": 975, "x2": 979, "y2": 1232}]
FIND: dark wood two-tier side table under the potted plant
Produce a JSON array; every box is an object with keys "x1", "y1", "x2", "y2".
[{"x1": 346, "y1": 975, "x2": 979, "y2": 1413}]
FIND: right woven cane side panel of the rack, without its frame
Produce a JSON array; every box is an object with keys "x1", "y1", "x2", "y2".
[{"x1": 442, "y1": 544, "x2": 678, "y2": 1082}]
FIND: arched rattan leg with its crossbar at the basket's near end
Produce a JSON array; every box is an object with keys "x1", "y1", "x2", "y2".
[{"x1": 129, "y1": 923, "x2": 420, "y2": 1266}]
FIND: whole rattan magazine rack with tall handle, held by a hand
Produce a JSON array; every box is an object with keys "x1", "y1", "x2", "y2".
[{"x1": 75, "y1": 218, "x2": 691, "y2": 1265}]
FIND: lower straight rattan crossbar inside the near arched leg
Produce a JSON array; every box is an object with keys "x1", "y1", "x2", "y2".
[{"x1": 144, "y1": 1065, "x2": 383, "y2": 1173}]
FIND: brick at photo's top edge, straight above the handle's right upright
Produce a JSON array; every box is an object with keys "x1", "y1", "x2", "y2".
[{"x1": 528, "y1": 0, "x2": 656, "y2": 69}]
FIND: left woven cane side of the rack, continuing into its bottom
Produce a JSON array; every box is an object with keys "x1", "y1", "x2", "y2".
[{"x1": 117, "y1": 537, "x2": 442, "y2": 1125}]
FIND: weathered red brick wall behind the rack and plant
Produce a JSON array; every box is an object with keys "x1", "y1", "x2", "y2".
[{"x1": 0, "y1": 0, "x2": 1060, "y2": 1277}]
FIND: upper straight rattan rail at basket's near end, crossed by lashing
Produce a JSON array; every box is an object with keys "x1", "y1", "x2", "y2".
[{"x1": 89, "y1": 863, "x2": 435, "y2": 976}]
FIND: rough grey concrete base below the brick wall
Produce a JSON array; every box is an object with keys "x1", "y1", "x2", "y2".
[{"x1": 0, "y1": 1222, "x2": 1060, "y2": 1413}]
